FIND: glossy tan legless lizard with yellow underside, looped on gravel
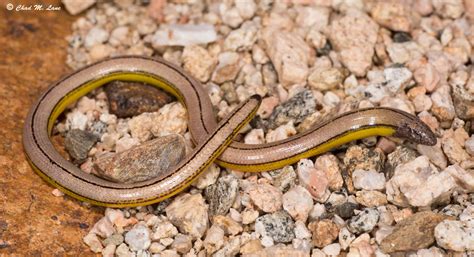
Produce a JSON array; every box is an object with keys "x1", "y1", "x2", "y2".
[{"x1": 23, "y1": 56, "x2": 436, "y2": 207}]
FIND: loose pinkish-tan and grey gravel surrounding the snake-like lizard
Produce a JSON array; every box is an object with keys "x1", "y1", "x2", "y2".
[{"x1": 55, "y1": 0, "x2": 474, "y2": 257}]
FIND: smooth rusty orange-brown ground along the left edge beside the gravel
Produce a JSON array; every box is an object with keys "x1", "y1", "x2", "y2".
[{"x1": 0, "y1": 0, "x2": 103, "y2": 256}]
